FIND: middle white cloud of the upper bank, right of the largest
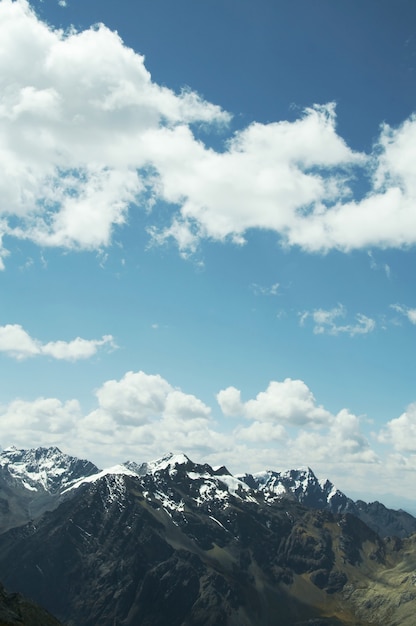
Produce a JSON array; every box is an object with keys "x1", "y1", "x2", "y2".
[{"x1": 153, "y1": 104, "x2": 363, "y2": 247}]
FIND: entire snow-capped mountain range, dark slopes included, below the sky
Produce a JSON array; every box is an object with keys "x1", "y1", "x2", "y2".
[{"x1": 0, "y1": 448, "x2": 416, "y2": 626}]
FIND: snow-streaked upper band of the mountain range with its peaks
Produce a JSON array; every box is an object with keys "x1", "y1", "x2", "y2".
[{"x1": 0, "y1": 447, "x2": 416, "y2": 536}]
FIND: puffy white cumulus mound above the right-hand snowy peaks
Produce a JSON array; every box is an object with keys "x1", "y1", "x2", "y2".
[{"x1": 217, "y1": 378, "x2": 378, "y2": 465}]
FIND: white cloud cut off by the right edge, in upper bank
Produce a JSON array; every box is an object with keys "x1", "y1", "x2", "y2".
[{"x1": 290, "y1": 115, "x2": 416, "y2": 250}]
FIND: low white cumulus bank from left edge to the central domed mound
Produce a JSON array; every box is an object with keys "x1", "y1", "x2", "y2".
[{"x1": 0, "y1": 371, "x2": 224, "y2": 465}]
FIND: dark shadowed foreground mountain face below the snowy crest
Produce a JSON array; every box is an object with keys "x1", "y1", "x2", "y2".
[{"x1": 0, "y1": 471, "x2": 370, "y2": 626}]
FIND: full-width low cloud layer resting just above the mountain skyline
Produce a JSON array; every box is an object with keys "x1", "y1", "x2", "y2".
[{"x1": 0, "y1": 371, "x2": 416, "y2": 497}]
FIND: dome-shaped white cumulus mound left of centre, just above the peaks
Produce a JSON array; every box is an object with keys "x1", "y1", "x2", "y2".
[{"x1": 78, "y1": 371, "x2": 223, "y2": 460}]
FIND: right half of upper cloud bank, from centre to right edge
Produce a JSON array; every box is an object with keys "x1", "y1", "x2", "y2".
[{"x1": 147, "y1": 105, "x2": 416, "y2": 255}]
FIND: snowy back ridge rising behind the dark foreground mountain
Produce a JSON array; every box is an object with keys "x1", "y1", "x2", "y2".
[{"x1": 0, "y1": 446, "x2": 416, "y2": 538}]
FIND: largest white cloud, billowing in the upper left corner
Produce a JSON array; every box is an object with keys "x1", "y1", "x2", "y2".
[{"x1": 0, "y1": 0, "x2": 229, "y2": 260}]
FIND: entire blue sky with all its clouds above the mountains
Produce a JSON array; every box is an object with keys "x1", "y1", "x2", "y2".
[{"x1": 0, "y1": 0, "x2": 416, "y2": 512}]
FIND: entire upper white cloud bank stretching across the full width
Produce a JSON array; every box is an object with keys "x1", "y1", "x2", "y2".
[{"x1": 0, "y1": 0, "x2": 416, "y2": 264}]
